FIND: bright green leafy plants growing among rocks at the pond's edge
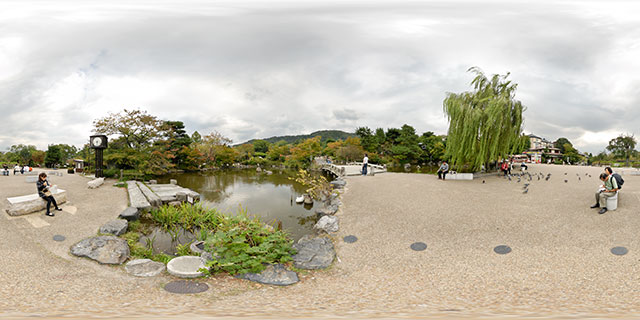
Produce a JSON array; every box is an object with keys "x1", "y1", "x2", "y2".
[{"x1": 150, "y1": 203, "x2": 295, "y2": 274}]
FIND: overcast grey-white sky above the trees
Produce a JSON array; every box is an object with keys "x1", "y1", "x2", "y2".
[{"x1": 0, "y1": 0, "x2": 640, "y2": 153}]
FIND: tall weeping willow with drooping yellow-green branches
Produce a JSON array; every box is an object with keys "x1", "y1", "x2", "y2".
[{"x1": 443, "y1": 67, "x2": 526, "y2": 171}]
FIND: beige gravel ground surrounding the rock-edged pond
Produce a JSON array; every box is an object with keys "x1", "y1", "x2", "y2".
[{"x1": 0, "y1": 165, "x2": 640, "y2": 319}]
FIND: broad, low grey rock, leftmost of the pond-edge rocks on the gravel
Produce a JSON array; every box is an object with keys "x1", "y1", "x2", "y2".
[{"x1": 71, "y1": 236, "x2": 129, "y2": 264}]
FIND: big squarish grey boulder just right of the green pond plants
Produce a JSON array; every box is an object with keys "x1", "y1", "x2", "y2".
[{"x1": 292, "y1": 235, "x2": 336, "y2": 269}]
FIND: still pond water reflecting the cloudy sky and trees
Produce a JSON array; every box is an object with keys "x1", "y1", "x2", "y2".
[{"x1": 157, "y1": 169, "x2": 321, "y2": 241}]
